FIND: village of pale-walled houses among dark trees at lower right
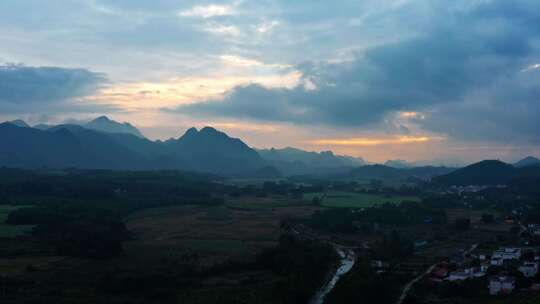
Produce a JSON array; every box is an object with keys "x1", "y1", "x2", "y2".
[{"x1": 394, "y1": 219, "x2": 540, "y2": 303}]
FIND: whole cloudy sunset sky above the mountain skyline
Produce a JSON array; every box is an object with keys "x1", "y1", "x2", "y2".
[{"x1": 0, "y1": 0, "x2": 540, "y2": 164}]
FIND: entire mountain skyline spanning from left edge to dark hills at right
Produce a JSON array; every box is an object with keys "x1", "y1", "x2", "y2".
[{"x1": 0, "y1": 116, "x2": 540, "y2": 179}]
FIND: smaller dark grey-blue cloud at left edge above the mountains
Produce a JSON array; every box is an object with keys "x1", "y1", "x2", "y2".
[{"x1": 0, "y1": 64, "x2": 107, "y2": 113}]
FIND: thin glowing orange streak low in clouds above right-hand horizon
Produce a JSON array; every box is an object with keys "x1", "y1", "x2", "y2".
[{"x1": 310, "y1": 136, "x2": 442, "y2": 146}]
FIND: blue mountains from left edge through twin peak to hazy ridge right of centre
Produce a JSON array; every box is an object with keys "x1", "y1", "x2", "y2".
[{"x1": 0, "y1": 116, "x2": 372, "y2": 177}]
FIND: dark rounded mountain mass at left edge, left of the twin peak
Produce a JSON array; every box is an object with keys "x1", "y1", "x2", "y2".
[{"x1": 0, "y1": 123, "x2": 150, "y2": 169}]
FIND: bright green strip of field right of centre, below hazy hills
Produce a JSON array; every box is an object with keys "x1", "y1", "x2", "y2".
[{"x1": 304, "y1": 191, "x2": 420, "y2": 208}]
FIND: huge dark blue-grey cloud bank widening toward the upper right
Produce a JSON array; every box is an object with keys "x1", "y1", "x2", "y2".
[{"x1": 171, "y1": 1, "x2": 540, "y2": 141}]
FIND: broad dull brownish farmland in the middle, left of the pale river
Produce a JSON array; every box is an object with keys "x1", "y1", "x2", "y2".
[{"x1": 124, "y1": 197, "x2": 316, "y2": 264}]
